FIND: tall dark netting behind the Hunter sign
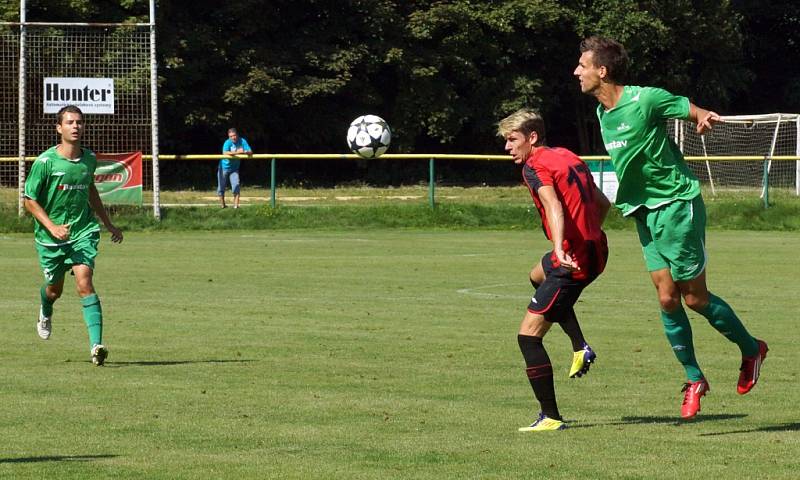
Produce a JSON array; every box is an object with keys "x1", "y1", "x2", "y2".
[{"x1": 0, "y1": 23, "x2": 153, "y2": 206}]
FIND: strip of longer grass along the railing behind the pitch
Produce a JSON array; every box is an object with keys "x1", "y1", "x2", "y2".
[{"x1": 0, "y1": 186, "x2": 800, "y2": 234}]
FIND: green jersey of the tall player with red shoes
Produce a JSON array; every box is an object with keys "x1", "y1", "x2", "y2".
[{"x1": 597, "y1": 86, "x2": 700, "y2": 215}]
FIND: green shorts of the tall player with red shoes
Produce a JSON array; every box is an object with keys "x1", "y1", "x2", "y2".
[{"x1": 632, "y1": 195, "x2": 707, "y2": 282}]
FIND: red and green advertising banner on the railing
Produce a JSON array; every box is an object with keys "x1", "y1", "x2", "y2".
[{"x1": 94, "y1": 152, "x2": 142, "y2": 206}]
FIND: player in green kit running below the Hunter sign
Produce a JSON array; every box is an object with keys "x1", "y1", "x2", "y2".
[{"x1": 25, "y1": 105, "x2": 122, "y2": 365}]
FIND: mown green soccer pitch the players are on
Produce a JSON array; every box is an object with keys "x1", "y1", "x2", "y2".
[{"x1": 0, "y1": 230, "x2": 800, "y2": 479}]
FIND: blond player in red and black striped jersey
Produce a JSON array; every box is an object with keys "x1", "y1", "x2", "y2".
[{"x1": 497, "y1": 110, "x2": 611, "y2": 432}]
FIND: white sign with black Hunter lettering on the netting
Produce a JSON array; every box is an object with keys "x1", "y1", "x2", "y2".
[{"x1": 44, "y1": 77, "x2": 114, "y2": 114}]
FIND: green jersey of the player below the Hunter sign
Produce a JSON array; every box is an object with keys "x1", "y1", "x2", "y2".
[{"x1": 25, "y1": 147, "x2": 100, "y2": 246}]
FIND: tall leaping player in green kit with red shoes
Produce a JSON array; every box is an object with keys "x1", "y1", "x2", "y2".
[{"x1": 574, "y1": 37, "x2": 768, "y2": 419}]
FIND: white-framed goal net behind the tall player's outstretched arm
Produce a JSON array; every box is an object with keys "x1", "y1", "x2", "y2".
[{"x1": 667, "y1": 113, "x2": 800, "y2": 196}]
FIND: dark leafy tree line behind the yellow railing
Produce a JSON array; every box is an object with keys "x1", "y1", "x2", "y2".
[{"x1": 0, "y1": 0, "x2": 800, "y2": 186}]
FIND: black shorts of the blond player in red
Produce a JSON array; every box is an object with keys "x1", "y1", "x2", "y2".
[{"x1": 528, "y1": 248, "x2": 597, "y2": 323}]
